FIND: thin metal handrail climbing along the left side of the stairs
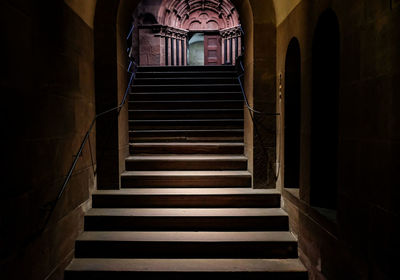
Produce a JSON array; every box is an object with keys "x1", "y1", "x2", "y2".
[{"x1": 41, "y1": 24, "x2": 137, "y2": 232}]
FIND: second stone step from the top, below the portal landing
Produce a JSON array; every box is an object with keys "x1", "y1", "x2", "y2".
[{"x1": 136, "y1": 69, "x2": 238, "y2": 78}]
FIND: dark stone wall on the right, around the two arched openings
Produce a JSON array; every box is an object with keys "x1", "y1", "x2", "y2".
[{"x1": 277, "y1": 0, "x2": 400, "y2": 279}]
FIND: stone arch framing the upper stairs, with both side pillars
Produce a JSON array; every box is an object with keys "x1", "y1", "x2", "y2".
[{"x1": 94, "y1": 0, "x2": 276, "y2": 189}]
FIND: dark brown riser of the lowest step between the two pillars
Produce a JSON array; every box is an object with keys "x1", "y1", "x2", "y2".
[{"x1": 121, "y1": 176, "x2": 251, "y2": 188}]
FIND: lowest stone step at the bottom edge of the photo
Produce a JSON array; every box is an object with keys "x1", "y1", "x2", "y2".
[{"x1": 65, "y1": 259, "x2": 308, "y2": 280}]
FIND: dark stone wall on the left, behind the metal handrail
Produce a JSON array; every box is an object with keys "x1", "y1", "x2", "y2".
[{"x1": 0, "y1": 0, "x2": 95, "y2": 279}]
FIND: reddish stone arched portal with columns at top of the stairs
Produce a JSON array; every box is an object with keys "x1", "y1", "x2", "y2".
[{"x1": 133, "y1": 0, "x2": 242, "y2": 66}]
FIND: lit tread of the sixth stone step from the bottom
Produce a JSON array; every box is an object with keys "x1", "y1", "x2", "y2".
[{"x1": 126, "y1": 154, "x2": 247, "y2": 161}]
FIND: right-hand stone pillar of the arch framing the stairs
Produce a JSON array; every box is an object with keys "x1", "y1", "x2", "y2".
[{"x1": 232, "y1": 1, "x2": 276, "y2": 188}]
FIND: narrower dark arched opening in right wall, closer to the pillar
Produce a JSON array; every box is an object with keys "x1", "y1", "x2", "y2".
[{"x1": 284, "y1": 38, "x2": 301, "y2": 188}]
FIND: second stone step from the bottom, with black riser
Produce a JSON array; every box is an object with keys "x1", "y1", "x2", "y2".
[{"x1": 75, "y1": 231, "x2": 298, "y2": 258}]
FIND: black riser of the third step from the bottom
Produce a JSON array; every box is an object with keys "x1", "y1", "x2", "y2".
[{"x1": 85, "y1": 216, "x2": 289, "y2": 231}]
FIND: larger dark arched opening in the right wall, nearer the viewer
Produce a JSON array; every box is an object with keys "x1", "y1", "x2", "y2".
[{"x1": 310, "y1": 9, "x2": 340, "y2": 209}]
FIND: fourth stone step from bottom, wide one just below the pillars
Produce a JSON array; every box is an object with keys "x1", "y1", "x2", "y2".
[{"x1": 92, "y1": 188, "x2": 280, "y2": 208}]
